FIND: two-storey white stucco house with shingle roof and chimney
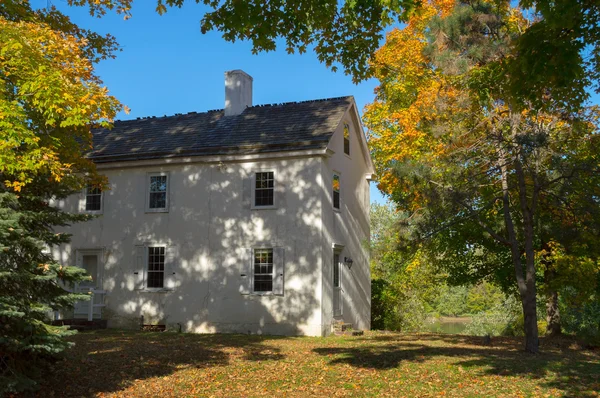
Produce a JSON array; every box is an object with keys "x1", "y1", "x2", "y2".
[{"x1": 55, "y1": 70, "x2": 373, "y2": 336}]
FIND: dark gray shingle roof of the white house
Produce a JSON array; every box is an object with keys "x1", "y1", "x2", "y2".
[{"x1": 88, "y1": 97, "x2": 353, "y2": 163}]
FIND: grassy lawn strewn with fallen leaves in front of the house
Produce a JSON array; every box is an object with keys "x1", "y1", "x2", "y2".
[{"x1": 38, "y1": 330, "x2": 600, "y2": 397}]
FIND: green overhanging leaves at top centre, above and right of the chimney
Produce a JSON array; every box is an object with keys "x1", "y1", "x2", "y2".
[{"x1": 157, "y1": 0, "x2": 418, "y2": 82}]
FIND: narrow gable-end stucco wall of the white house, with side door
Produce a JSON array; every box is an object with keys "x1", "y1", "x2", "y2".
[{"x1": 321, "y1": 107, "x2": 371, "y2": 330}]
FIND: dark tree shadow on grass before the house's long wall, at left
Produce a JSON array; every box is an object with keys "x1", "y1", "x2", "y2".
[{"x1": 36, "y1": 330, "x2": 284, "y2": 397}]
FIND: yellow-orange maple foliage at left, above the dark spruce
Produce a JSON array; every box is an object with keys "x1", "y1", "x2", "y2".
[{"x1": 0, "y1": 17, "x2": 122, "y2": 192}]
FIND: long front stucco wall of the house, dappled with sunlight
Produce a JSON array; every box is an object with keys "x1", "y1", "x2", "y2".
[{"x1": 55, "y1": 157, "x2": 328, "y2": 335}]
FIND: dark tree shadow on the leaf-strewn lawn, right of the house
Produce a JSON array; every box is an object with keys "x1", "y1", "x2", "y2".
[{"x1": 313, "y1": 334, "x2": 600, "y2": 397}]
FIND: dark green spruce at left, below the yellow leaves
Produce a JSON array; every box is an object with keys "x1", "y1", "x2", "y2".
[{"x1": 0, "y1": 178, "x2": 89, "y2": 393}]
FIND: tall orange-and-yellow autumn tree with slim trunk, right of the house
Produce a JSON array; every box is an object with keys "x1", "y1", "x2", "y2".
[{"x1": 365, "y1": 1, "x2": 600, "y2": 352}]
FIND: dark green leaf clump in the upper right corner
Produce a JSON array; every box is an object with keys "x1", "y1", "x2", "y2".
[{"x1": 509, "y1": 0, "x2": 600, "y2": 109}]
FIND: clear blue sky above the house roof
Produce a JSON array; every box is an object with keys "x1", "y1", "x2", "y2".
[{"x1": 44, "y1": 0, "x2": 600, "y2": 202}]
